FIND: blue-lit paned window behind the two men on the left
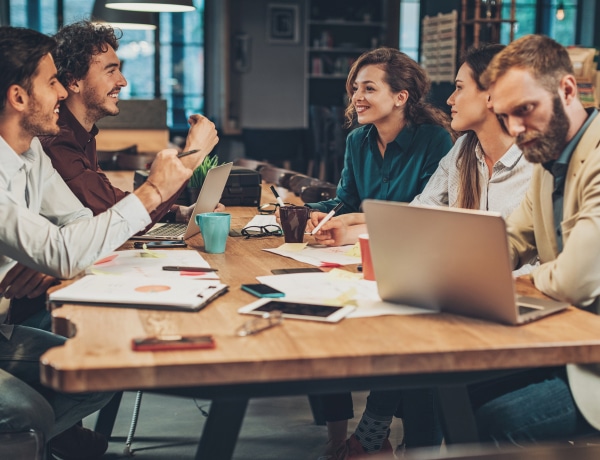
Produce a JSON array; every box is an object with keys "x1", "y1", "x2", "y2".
[{"x1": 9, "y1": 0, "x2": 204, "y2": 133}]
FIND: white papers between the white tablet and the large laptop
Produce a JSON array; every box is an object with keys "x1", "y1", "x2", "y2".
[{"x1": 256, "y1": 270, "x2": 435, "y2": 318}]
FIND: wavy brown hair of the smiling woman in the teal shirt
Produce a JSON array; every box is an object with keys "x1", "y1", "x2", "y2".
[{"x1": 345, "y1": 48, "x2": 455, "y2": 137}]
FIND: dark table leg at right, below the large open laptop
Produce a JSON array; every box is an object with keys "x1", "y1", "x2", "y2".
[{"x1": 437, "y1": 385, "x2": 479, "y2": 444}]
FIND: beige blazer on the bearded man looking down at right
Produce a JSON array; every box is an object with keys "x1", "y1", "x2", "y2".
[{"x1": 507, "y1": 114, "x2": 600, "y2": 430}]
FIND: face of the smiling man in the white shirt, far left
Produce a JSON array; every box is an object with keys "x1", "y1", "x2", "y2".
[{"x1": 20, "y1": 54, "x2": 67, "y2": 137}]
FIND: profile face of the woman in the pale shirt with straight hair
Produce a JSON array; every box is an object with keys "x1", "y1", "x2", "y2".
[{"x1": 447, "y1": 64, "x2": 493, "y2": 131}]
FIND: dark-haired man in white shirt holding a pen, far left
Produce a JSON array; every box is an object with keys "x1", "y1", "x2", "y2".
[{"x1": 0, "y1": 27, "x2": 213, "y2": 460}]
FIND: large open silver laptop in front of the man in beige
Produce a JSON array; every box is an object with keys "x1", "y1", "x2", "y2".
[{"x1": 363, "y1": 200, "x2": 569, "y2": 324}]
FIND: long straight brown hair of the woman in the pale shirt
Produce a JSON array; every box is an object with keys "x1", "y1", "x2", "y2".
[{"x1": 451, "y1": 44, "x2": 504, "y2": 209}]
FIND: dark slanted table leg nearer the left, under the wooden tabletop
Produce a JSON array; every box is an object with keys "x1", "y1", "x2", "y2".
[{"x1": 196, "y1": 398, "x2": 248, "y2": 460}]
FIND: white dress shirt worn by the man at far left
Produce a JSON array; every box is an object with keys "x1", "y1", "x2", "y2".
[{"x1": 0, "y1": 136, "x2": 150, "y2": 332}]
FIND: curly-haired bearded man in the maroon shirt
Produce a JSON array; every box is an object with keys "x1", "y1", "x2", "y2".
[{"x1": 0, "y1": 21, "x2": 218, "y2": 330}]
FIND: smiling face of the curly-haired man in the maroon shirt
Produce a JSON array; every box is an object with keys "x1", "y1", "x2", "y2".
[{"x1": 77, "y1": 45, "x2": 127, "y2": 123}]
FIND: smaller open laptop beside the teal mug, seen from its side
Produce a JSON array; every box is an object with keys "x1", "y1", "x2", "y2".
[{"x1": 132, "y1": 163, "x2": 233, "y2": 240}]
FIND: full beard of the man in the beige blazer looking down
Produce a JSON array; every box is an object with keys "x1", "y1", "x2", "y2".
[{"x1": 516, "y1": 96, "x2": 570, "y2": 164}]
